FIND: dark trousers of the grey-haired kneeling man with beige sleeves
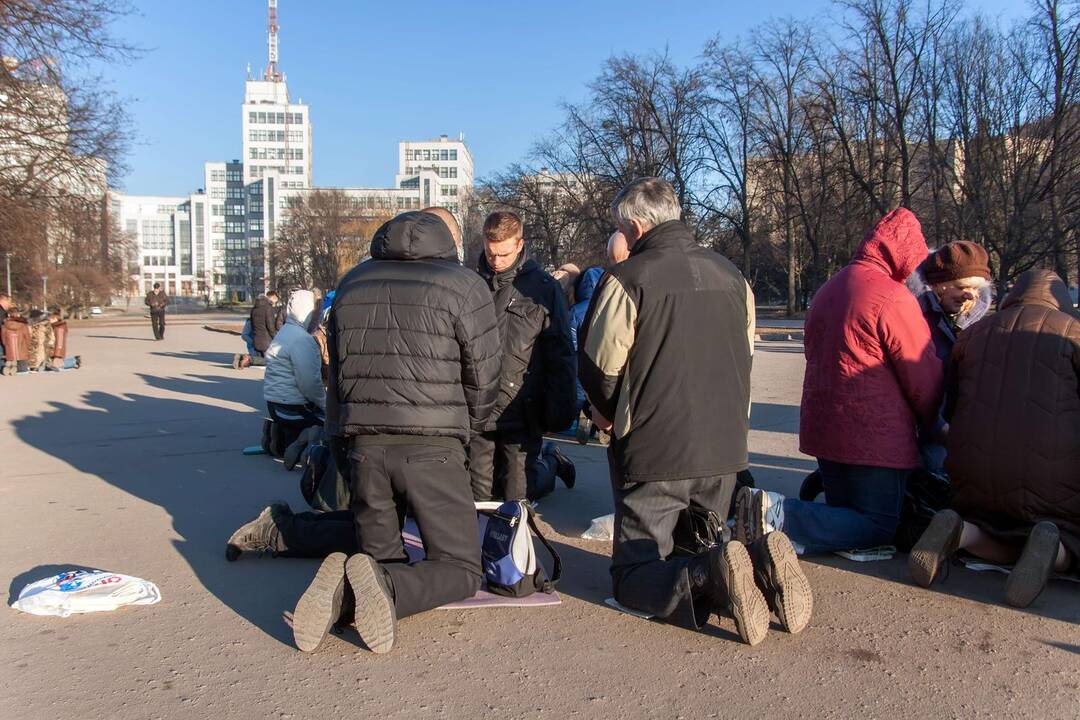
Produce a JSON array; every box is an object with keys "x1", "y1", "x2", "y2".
[{"x1": 608, "y1": 456, "x2": 735, "y2": 629}]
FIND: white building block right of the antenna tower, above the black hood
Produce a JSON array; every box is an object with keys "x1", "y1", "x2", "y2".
[{"x1": 394, "y1": 135, "x2": 473, "y2": 220}]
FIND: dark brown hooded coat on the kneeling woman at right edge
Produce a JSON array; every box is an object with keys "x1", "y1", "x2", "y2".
[{"x1": 945, "y1": 270, "x2": 1080, "y2": 557}]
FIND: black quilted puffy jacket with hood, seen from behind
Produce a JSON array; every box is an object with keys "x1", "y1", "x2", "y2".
[{"x1": 326, "y1": 213, "x2": 499, "y2": 444}]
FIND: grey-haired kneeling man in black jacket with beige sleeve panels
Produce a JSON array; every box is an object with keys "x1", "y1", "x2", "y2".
[{"x1": 578, "y1": 178, "x2": 812, "y2": 644}]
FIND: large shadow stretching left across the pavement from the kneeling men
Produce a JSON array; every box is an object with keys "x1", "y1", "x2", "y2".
[{"x1": 12, "y1": 378, "x2": 316, "y2": 646}]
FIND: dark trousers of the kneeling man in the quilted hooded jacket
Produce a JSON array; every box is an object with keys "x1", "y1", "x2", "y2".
[{"x1": 349, "y1": 437, "x2": 482, "y2": 617}]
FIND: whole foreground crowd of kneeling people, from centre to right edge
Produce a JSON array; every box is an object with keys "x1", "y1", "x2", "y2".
[{"x1": 226, "y1": 178, "x2": 1080, "y2": 653}]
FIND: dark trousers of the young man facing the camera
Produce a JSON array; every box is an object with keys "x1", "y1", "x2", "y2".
[{"x1": 469, "y1": 431, "x2": 555, "y2": 502}]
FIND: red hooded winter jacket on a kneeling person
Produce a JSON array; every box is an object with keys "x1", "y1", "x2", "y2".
[{"x1": 799, "y1": 208, "x2": 943, "y2": 468}]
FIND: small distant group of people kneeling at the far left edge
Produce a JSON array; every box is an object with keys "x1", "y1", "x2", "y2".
[{"x1": 0, "y1": 293, "x2": 82, "y2": 376}]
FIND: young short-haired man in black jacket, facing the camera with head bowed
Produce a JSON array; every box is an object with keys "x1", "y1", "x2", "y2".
[{"x1": 469, "y1": 212, "x2": 577, "y2": 501}]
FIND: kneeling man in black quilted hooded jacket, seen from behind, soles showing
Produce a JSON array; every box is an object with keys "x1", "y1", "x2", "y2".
[{"x1": 293, "y1": 213, "x2": 499, "y2": 653}]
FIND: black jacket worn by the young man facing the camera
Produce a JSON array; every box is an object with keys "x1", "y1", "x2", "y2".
[{"x1": 477, "y1": 253, "x2": 578, "y2": 434}]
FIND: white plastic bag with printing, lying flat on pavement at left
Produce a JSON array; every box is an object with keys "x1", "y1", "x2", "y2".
[{"x1": 11, "y1": 570, "x2": 161, "y2": 617}]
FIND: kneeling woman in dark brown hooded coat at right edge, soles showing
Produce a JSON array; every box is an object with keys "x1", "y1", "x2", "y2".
[{"x1": 908, "y1": 270, "x2": 1080, "y2": 607}]
